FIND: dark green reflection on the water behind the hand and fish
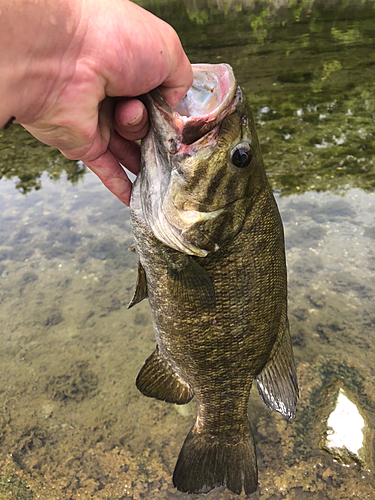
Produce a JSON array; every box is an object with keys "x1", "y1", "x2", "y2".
[{"x1": 0, "y1": 0, "x2": 375, "y2": 194}]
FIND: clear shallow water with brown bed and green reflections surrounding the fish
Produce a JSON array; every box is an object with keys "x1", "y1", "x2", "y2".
[{"x1": 0, "y1": 0, "x2": 375, "y2": 500}]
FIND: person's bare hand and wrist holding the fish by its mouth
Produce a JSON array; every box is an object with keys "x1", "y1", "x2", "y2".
[{"x1": 0, "y1": 0, "x2": 192, "y2": 205}]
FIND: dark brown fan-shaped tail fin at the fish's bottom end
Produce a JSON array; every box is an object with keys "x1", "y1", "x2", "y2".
[{"x1": 173, "y1": 427, "x2": 258, "y2": 495}]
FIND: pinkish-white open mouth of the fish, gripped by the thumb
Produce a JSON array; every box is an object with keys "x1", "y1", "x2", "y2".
[{"x1": 149, "y1": 64, "x2": 238, "y2": 145}]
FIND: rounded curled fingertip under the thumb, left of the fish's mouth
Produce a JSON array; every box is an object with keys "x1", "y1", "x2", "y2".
[{"x1": 115, "y1": 99, "x2": 148, "y2": 141}]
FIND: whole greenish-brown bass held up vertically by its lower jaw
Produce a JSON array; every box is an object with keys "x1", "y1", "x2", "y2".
[{"x1": 128, "y1": 64, "x2": 298, "y2": 494}]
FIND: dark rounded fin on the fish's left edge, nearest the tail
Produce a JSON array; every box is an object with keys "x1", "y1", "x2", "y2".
[{"x1": 136, "y1": 347, "x2": 194, "y2": 405}]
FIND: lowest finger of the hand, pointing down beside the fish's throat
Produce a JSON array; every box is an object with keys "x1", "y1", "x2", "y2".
[{"x1": 84, "y1": 150, "x2": 132, "y2": 206}]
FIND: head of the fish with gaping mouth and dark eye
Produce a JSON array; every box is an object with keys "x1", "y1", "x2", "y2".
[{"x1": 136, "y1": 64, "x2": 263, "y2": 257}]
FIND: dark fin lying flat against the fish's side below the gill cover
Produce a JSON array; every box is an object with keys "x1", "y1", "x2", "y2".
[{"x1": 164, "y1": 252, "x2": 216, "y2": 312}]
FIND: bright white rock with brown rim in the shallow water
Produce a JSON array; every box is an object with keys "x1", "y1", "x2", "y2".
[{"x1": 319, "y1": 380, "x2": 373, "y2": 468}]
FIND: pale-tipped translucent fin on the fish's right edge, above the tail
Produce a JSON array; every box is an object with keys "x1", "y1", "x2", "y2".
[{"x1": 257, "y1": 323, "x2": 298, "y2": 420}]
